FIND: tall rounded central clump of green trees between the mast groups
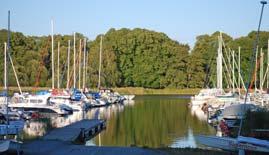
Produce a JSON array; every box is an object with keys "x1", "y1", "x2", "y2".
[{"x1": 90, "y1": 29, "x2": 189, "y2": 88}]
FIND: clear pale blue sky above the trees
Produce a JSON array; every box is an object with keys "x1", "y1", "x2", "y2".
[{"x1": 0, "y1": 0, "x2": 269, "y2": 47}]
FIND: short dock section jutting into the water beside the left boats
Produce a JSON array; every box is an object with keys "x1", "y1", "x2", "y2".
[{"x1": 43, "y1": 119, "x2": 106, "y2": 143}]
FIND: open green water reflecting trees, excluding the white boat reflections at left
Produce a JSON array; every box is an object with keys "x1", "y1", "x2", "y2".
[{"x1": 94, "y1": 96, "x2": 214, "y2": 147}]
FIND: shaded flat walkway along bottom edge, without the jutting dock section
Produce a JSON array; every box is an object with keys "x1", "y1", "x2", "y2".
[{"x1": 23, "y1": 140, "x2": 165, "y2": 155}]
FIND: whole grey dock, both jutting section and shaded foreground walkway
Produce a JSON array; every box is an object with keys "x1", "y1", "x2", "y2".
[{"x1": 22, "y1": 119, "x2": 162, "y2": 155}]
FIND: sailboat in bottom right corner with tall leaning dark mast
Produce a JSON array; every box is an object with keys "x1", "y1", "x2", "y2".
[{"x1": 195, "y1": 1, "x2": 269, "y2": 155}]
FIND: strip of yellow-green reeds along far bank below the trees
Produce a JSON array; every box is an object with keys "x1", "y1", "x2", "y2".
[{"x1": 0, "y1": 87, "x2": 201, "y2": 95}]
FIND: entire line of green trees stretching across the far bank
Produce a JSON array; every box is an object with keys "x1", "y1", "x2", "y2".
[{"x1": 0, "y1": 28, "x2": 269, "y2": 88}]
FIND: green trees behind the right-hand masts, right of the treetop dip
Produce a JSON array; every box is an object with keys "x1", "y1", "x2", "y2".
[{"x1": 187, "y1": 31, "x2": 269, "y2": 88}]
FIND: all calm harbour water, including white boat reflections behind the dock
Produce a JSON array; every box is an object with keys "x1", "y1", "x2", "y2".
[{"x1": 23, "y1": 96, "x2": 215, "y2": 147}]
